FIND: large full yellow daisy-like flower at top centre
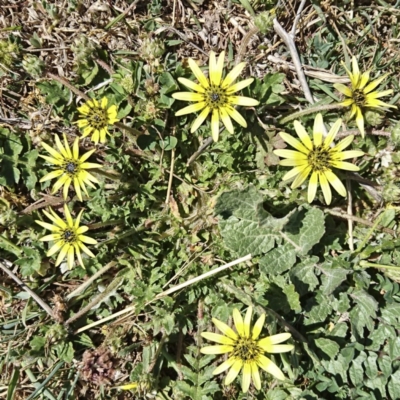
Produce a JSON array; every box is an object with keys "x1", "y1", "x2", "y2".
[{"x1": 172, "y1": 51, "x2": 259, "y2": 142}]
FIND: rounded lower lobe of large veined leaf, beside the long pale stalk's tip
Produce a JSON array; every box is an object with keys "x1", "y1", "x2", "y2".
[{"x1": 259, "y1": 243, "x2": 296, "y2": 275}]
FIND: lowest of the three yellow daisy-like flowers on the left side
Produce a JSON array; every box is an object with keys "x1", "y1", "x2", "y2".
[{"x1": 35, "y1": 204, "x2": 97, "y2": 269}]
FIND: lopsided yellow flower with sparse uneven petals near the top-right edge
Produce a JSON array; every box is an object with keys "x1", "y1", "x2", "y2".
[{"x1": 333, "y1": 57, "x2": 397, "y2": 137}]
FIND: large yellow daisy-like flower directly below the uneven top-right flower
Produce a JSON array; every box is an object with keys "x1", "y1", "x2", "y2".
[{"x1": 274, "y1": 114, "x2": 364, "y2": 204}]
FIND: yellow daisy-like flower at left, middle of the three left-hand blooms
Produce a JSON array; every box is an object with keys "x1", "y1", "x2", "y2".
[{"x1": 40, "y1": 134, "x2": 102, "y2": 201}]
